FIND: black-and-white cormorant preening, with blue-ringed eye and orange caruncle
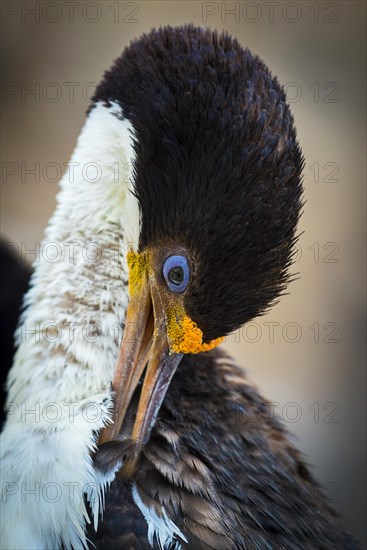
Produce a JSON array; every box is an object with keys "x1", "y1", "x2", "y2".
[{"x1": 1, "y1": 25, "x2": 356, "y2": 550}]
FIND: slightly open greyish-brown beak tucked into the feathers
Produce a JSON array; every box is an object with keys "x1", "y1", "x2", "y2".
[{"x1": 99, "y1": 260, "x2": 183, "y2": 477}]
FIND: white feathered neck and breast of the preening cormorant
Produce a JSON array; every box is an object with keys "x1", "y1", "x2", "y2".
[{"x1": 1, "y1": 104, "x2": 139, "y2": 548}]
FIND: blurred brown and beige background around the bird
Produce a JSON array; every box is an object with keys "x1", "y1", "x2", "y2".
[{"x1": 1, "y1": 0, "x2": 366, "y2": 541}]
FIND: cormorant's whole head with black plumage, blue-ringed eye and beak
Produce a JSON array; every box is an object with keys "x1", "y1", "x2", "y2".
[{"x1": 94, "y1": 25, "x2": 303, "y2": 472}]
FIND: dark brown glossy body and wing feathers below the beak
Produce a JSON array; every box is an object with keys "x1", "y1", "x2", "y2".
[{"x1": 87, "y1": 350, "x2": 357, "y2": 550}]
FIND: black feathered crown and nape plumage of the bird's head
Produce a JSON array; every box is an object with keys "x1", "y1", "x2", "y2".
[{"x1": 94, "y1": 25, "x2": 303, "y2": 340}]
